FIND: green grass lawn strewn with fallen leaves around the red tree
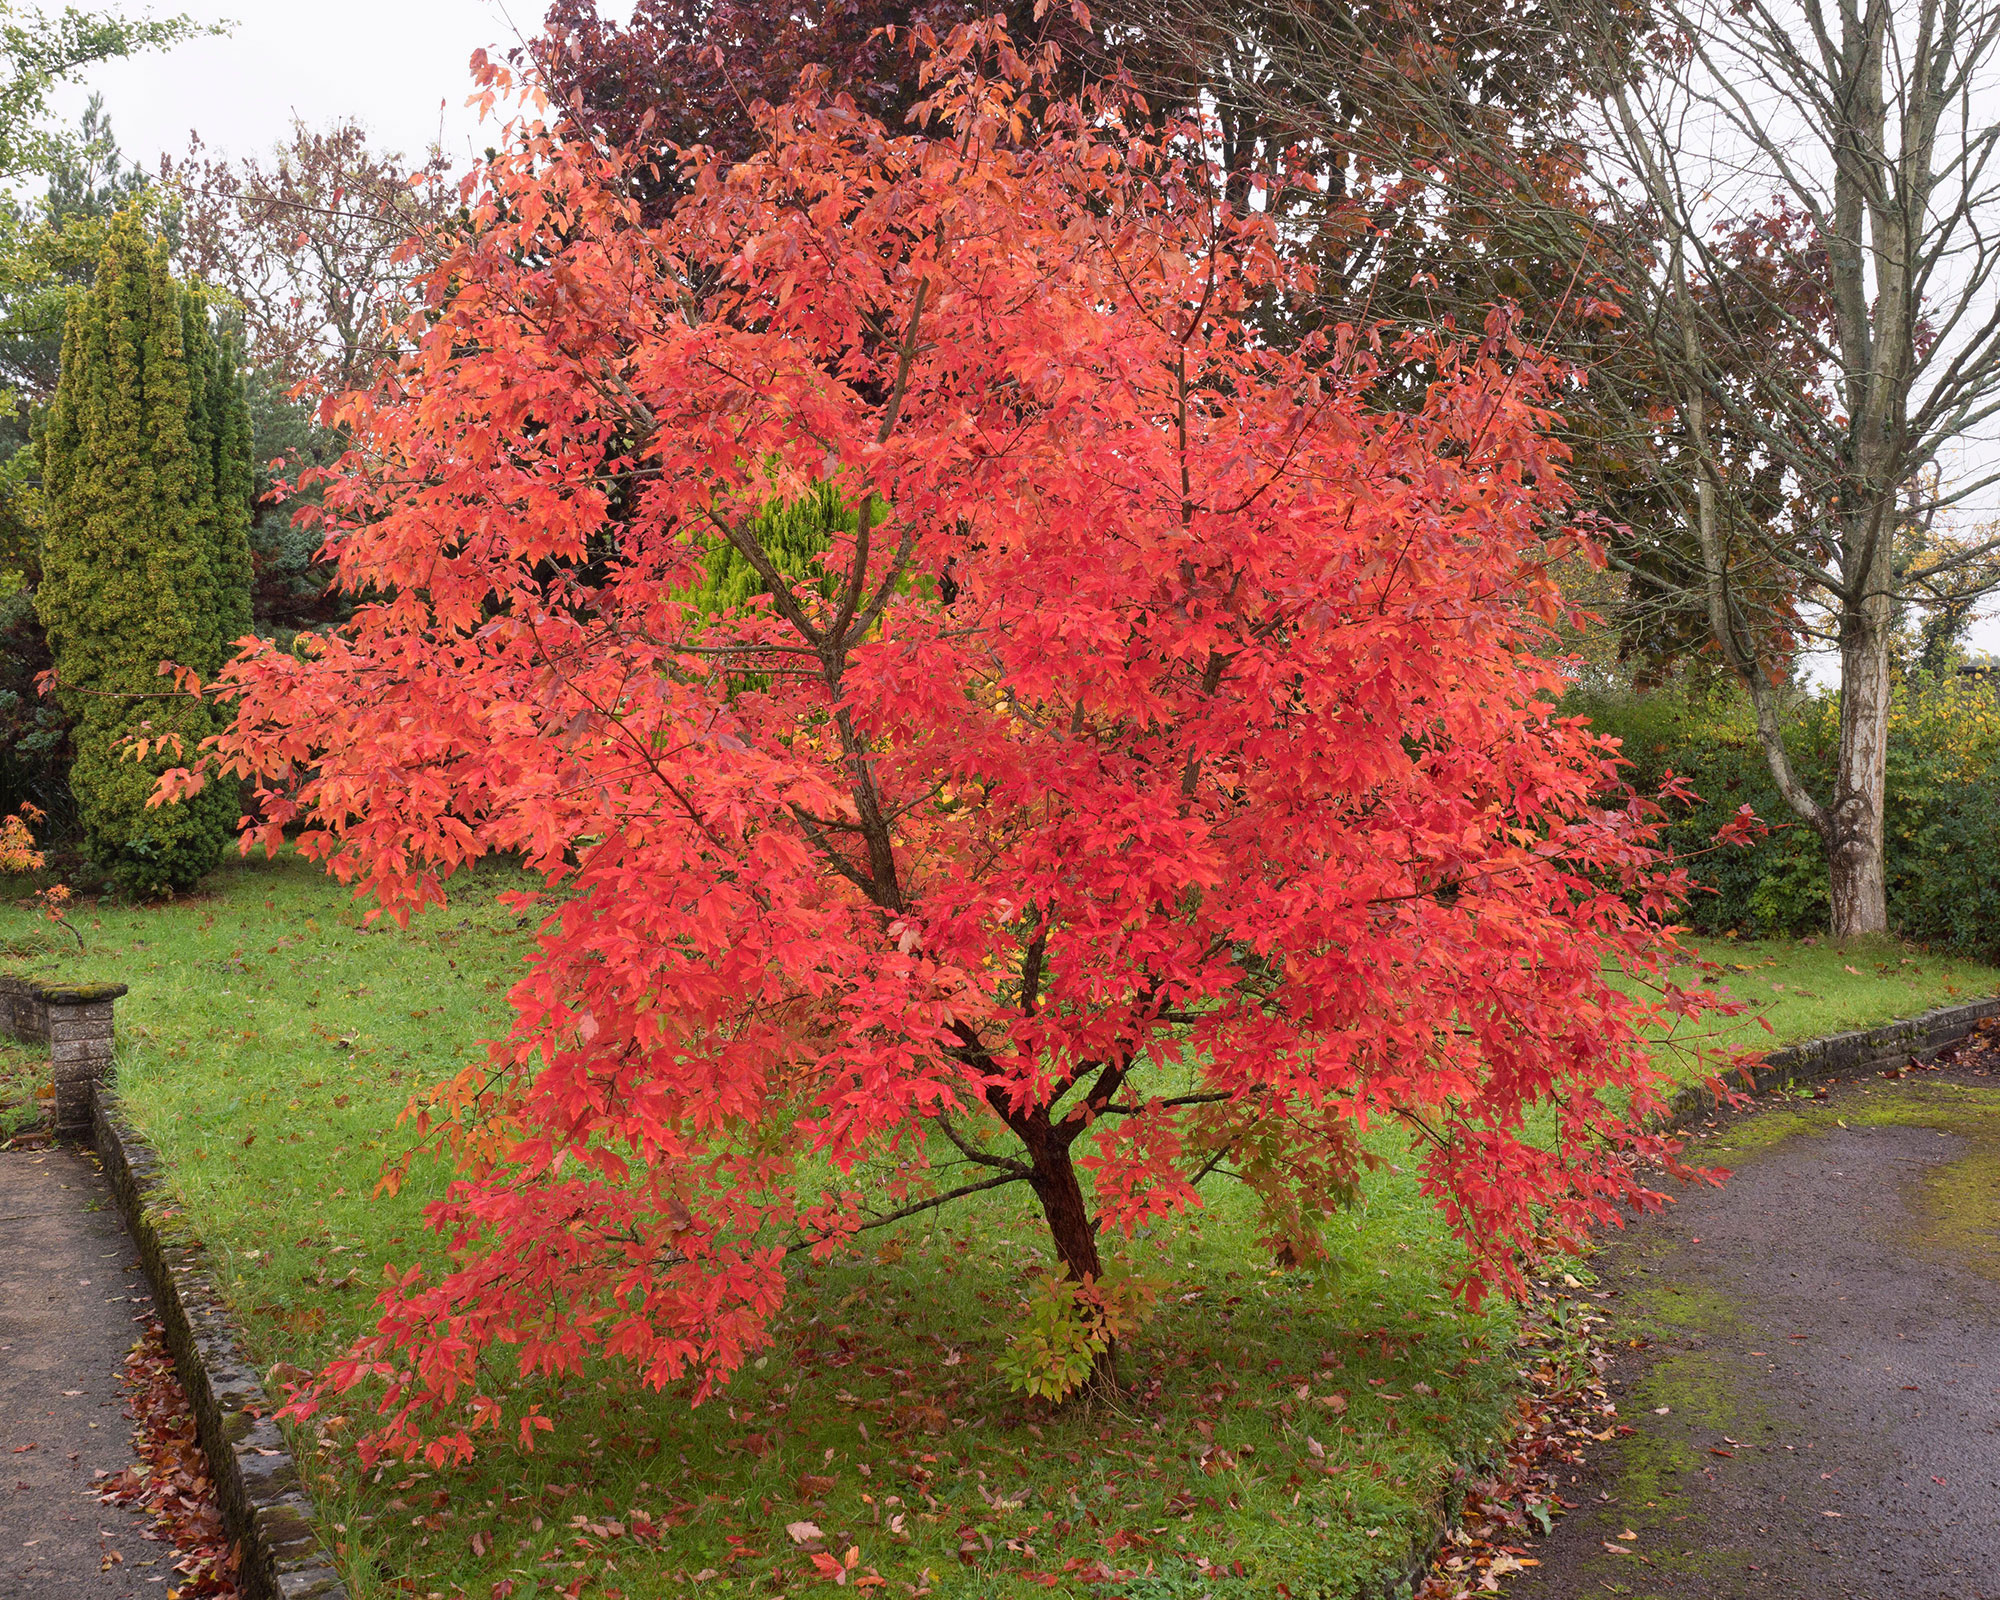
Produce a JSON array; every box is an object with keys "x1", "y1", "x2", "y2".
[{"x1": 0, "y1": 860, "x2": 2000, "y2": 1600}]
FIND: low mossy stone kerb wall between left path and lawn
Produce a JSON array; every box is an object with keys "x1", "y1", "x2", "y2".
[{"x1": 92, "y1": 1084, "x2": 348, "y2": 1600}]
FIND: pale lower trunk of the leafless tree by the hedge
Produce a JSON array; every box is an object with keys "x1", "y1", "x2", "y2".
[{"x1": 1826, "y1": 600, "x2": 1890, "y2": 938}]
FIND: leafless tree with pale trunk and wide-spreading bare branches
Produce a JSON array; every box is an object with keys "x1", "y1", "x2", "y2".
[{"x1": 1160, "y1": 0, "x2": 2000, "y2": 934}]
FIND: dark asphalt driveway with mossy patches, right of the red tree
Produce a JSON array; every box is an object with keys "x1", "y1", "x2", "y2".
[{"x1": 1506, "y1": 1046, "x2": 2000, "y2": 1600}]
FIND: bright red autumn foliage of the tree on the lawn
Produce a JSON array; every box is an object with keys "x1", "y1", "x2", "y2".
[{"x1": 180, "y1": 30, "x2": 1728, "y2": 1460}]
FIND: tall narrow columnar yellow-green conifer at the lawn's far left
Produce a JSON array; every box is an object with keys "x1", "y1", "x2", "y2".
[{"x1": 36, "y1": 210, "x2": 250, "y2": 896}]
